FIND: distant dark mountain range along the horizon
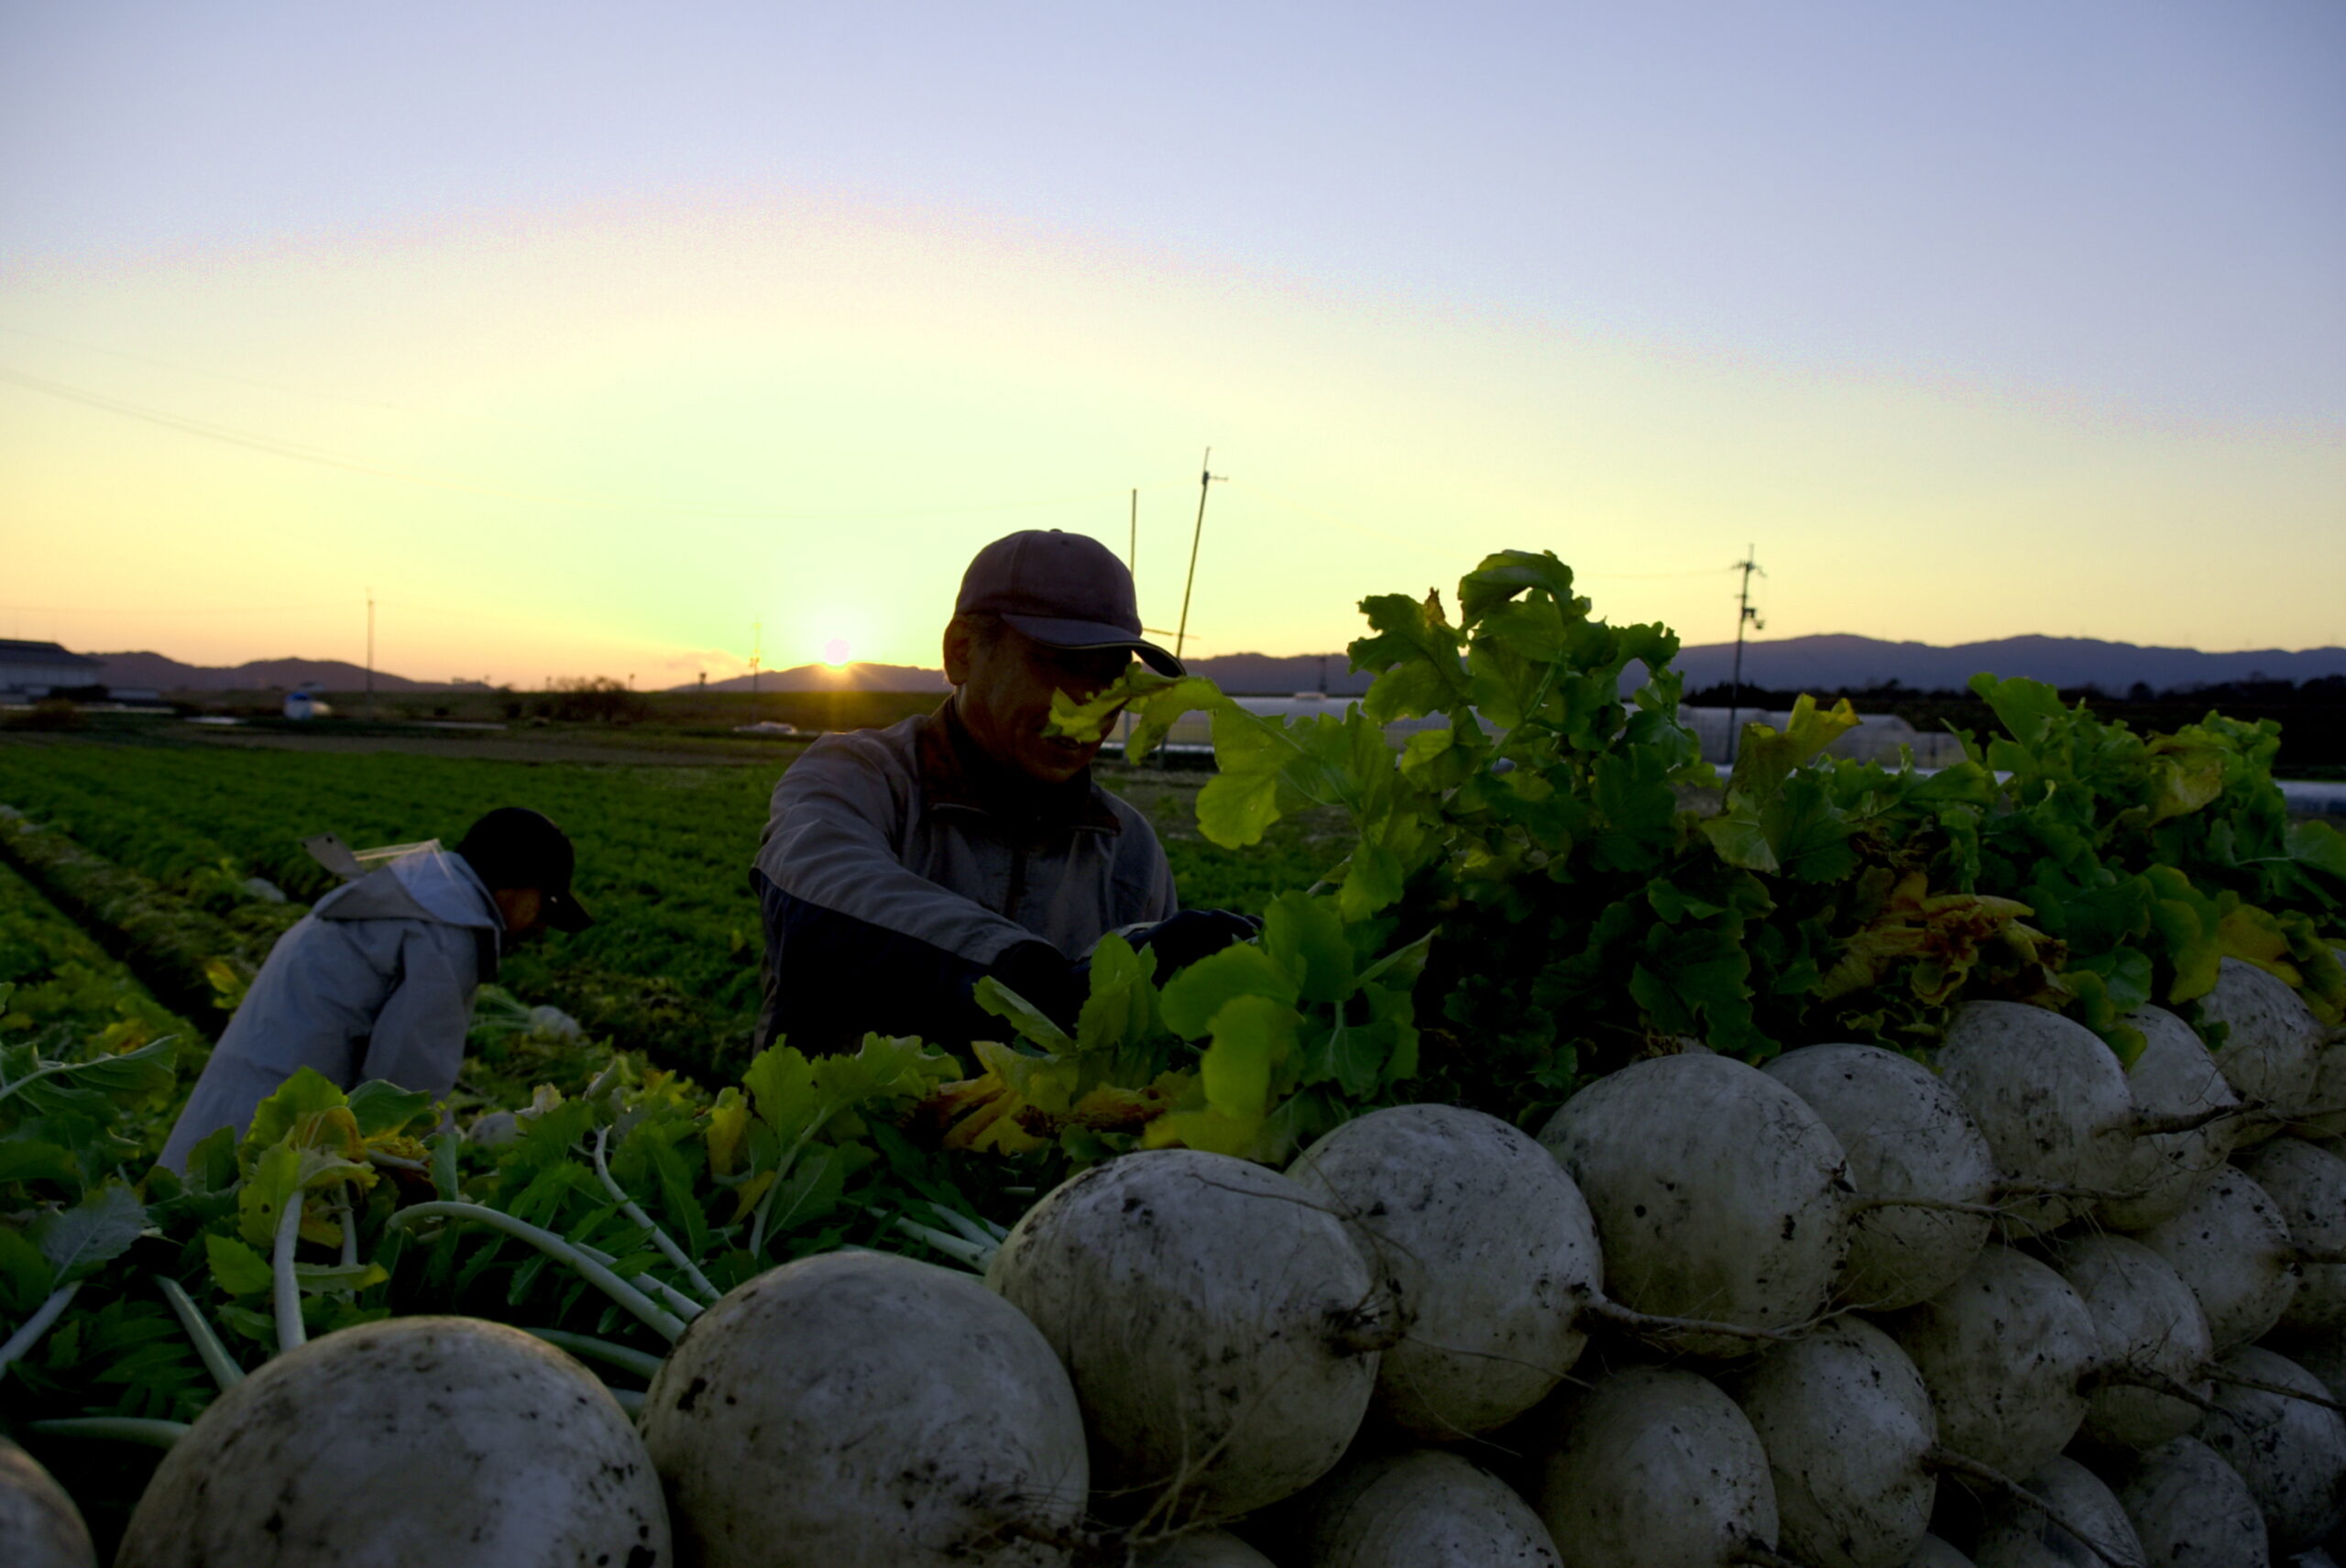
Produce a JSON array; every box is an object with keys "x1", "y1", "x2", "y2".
[{"x1": 92, "y1": 634, "x2": 2346, "y2": 697}]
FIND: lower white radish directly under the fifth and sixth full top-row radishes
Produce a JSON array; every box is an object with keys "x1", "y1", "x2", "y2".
[{"x1": 1725, "y1": 1317, "x2": 1938, "y2": 1568}]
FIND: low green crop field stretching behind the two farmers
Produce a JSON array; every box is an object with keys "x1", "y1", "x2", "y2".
[{"x1": 0, "y1": 725, "x2": 1340, "y2": 1070}]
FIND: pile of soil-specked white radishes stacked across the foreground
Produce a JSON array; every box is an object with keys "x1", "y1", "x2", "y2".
[{"x1": 64, "y1": 962, "x2": 2346, "y2": 1568}]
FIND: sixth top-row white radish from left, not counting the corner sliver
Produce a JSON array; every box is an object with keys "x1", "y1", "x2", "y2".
[{"x1": 1762, "y1": 1045, "x2": 1997, "y2": 1312}]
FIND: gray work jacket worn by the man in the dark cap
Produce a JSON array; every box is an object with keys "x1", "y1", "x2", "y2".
[{"x1": 751, "y1": 704, "x2": 1180, "y2": 1051}]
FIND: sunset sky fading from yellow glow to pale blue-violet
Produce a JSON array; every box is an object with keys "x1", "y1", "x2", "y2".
[{"x1": 0, "y1": 0, "x2": 2346, "y2": 685}]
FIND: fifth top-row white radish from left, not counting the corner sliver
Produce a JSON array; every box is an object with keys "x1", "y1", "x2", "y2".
[{"x1": 1539, "y1": 1054, "x2": 1851, "y2": 1356}]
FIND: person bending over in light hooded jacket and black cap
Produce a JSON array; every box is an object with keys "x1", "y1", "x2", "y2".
[{"x1": 162, "y1": 806, "x2": 591, "y2": 1171}]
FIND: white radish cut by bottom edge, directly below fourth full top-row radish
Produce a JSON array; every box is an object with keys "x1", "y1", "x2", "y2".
[{"x1": 1288, "y1": 1448, "x2": 1560, "y2": 1568}]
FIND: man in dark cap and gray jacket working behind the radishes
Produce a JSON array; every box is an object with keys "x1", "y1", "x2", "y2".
[{"x1": 751, "y1": 528, "x2": 1255, "y2": 1054}]
